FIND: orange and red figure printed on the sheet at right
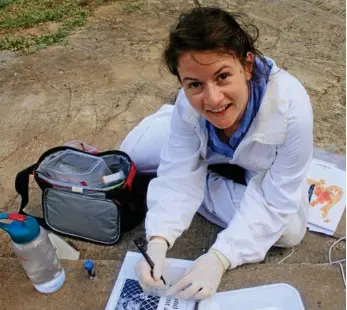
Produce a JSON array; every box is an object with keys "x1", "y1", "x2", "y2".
[{"x1": 307, "y1": 178, "x2": 343, "y2": 222}]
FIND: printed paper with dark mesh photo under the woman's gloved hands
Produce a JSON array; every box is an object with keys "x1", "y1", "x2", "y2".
[{"x1": 105, "y1": 252, "x2": 195, "y2": 310}]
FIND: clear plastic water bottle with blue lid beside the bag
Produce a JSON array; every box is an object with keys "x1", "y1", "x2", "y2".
[{"x1": 0, "y1": 213, "x2": 65, "y2": 294}]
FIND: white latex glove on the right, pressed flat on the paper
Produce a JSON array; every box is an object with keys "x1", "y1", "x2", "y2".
[{"x1": 166, "y1": 249, "x2": 230, "y2": 300}]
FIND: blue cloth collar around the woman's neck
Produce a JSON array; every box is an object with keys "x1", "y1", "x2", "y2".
[{"x1": 206, "y1": 58, "x2": 273, "y2": 158}]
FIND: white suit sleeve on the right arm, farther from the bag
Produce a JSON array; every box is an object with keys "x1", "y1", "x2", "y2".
[{"x1": 212, "y1": 95, "x2": 313, "y2": 269}]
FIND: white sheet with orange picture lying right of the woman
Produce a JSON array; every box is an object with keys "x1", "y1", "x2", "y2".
[{"x1": 308, "y1": 159, "x2": 346, "y2": 235}]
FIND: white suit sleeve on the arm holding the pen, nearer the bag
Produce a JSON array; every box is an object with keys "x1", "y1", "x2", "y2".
[{"x1": 145, "y1": 91, "x2": 207, "y2": 248}]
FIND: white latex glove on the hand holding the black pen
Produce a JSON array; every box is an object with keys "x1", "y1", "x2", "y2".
[{"x1": 136, "y1": 238, "x2": 168, "y2": 291}]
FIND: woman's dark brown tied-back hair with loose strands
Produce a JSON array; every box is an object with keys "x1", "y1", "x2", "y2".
[{"x1": 163, "y1": 6, "x2": 268, "y2": 82}]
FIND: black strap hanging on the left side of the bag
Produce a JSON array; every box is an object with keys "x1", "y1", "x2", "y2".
[{"x1": 15, "y1": 164, "x2": 50, "y2": 229}]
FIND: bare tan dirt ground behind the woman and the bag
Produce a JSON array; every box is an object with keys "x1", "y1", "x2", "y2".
[{"x1": 0, "y1": 0, "x2": 346, "y2": 258}]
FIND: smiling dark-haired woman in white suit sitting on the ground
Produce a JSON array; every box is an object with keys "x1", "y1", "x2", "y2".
[{"x1": 121, "y1": 7, "x2": 313, "y2": 299}]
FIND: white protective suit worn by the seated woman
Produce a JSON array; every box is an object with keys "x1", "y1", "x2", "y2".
[{"x1": 121, "y1": 60, "x2": 313, "y2": 268}]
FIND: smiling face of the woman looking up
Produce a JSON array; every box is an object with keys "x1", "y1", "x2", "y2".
[{"x1": 178, "y1": 51, "x2": 253, "y2": 129}]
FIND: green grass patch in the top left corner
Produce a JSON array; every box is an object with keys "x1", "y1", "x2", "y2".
[{"x1": 0, "y1": 0, "x2": 112, "y2": 52}]
